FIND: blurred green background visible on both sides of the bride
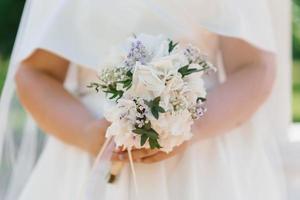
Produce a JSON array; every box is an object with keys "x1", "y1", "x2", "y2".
[{"x1": 0, "y1": 0, "x2": 300, "y2": 122}]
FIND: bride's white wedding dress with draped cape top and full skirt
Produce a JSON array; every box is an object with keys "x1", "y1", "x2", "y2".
[{"x1": 0, "y1": 0, "x2": 286, "y2": 200}]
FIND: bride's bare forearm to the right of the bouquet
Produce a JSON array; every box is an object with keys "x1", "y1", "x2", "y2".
[{"x1": 193, "y1": 64, "x2": 275, "y2": 139}]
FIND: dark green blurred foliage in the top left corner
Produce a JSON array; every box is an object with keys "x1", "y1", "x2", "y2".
[{"x1": 0, "y1": 0, "x2": 25, "y2": 57}]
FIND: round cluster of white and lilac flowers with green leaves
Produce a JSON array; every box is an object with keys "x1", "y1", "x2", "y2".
[{"x1": 88, "y1": 34, "x2": 215, "y2": 181}]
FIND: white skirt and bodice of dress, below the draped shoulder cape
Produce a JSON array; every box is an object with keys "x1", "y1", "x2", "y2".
[{"x1": 20, "y1": 62, "x2": 284, "y2": 200}]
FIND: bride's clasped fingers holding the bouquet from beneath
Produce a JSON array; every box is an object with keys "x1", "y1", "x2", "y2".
[{"x1": 112, "y1": 142, "x2": 189, "y2": 164}]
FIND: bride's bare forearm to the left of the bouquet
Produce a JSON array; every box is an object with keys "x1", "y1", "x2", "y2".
[{"x1": 16, "y1": 66, "x2": 107, "y2": 154}]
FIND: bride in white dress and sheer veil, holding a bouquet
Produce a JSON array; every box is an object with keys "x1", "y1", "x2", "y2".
[{"x1": 0, "y1": 0, "x2": 288, "y2": 200}]
